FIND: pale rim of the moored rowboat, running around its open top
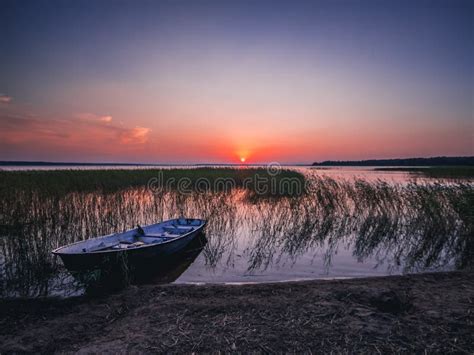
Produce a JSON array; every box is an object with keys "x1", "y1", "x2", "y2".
[{"x1": 51, "y1": 218, "x2": 207, "y2": 256}]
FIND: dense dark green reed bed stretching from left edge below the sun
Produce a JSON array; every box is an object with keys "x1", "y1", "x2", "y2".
[{"x1": 0, "y1": 167, "x2": 305, "y2": 196}]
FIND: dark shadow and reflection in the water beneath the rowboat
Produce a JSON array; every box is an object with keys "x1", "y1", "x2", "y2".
[{"x1": 71, "y1": 233, "x2": 207, "y2": 295}]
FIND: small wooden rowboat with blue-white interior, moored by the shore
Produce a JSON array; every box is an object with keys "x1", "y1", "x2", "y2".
[{"x1": 52, "y1": 218, "x2": 206, "y2": 272}]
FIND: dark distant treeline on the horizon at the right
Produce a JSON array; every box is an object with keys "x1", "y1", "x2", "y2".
[{"x1": 313, "y1": 157, "x2": 474, "y2": 166}]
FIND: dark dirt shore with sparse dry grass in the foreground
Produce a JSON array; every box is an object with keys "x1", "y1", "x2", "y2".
[{"x1": 0, "y1": 271, "x2": 474, "y2": 354}]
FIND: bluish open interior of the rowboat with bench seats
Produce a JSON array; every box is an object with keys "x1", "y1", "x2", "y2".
[{"x1": 60, "y1": 218, "x2": 204, "y2": 253}]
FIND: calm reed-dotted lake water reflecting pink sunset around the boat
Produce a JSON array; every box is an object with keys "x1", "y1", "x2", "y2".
[{"x1": 0, "y1": 167, "x2": 473, "y2": 297}]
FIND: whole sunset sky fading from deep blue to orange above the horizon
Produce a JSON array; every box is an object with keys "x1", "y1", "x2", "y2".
[{"x1": 0, "y1": 0, "x2": 474, "y2": 164}]
